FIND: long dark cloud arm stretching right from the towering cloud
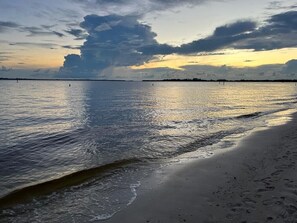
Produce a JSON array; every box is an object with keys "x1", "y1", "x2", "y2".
[{"x1": 141, "y1": 11, "x2": 297, "y2": 55}]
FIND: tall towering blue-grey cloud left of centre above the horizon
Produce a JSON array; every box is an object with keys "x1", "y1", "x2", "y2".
[{"x1": 60, "y1": 15, "x2": 157, "y2": 77}]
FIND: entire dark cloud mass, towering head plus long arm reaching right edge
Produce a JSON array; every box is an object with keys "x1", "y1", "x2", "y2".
[{"x1": 60, "y1": 10, "x2": 297, "y2": 77}]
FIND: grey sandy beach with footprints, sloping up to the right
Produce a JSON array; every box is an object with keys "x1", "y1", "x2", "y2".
[{"x1": 104, "y1": 114, "x2": 297, "y2": 223}]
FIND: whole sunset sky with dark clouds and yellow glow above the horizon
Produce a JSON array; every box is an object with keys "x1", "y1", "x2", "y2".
[{"x1": 0, "y1": 0, "x2": 297, "y2": 80}]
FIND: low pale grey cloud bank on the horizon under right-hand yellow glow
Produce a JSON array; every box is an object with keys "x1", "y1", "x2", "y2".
[{"x1": 110, "y1": 61, "x2": 293, "y2": 80}]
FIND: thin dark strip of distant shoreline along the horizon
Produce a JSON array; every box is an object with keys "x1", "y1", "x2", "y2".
[{"x1": 0, "y1": 77, "x2": 297, "y2": 83}]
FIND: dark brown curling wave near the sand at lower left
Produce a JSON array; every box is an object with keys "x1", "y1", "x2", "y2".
[{"x1": 0, "y1": 158, "x2": 145, "y2": 208}]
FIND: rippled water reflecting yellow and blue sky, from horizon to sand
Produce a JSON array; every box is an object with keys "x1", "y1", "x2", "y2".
[{"x1": 0, "y1": 81, "x2": 297, "y2": 222}]
